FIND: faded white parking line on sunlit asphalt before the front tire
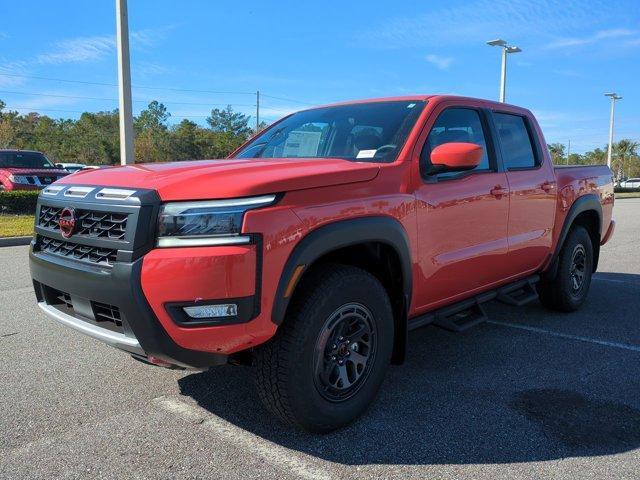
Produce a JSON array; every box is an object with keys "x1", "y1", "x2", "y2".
[{"x1": 152, "y1": 397, "x2": 333, "y2": 480}]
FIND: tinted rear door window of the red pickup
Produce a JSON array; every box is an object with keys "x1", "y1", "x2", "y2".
[{"x1": 493, "y1": 113, "x2": 538, "y2": 170}]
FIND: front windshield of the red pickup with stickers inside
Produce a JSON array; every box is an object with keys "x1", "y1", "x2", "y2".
[{"x1": 236, "y1": 100, "x2": 425, "y2": 162}]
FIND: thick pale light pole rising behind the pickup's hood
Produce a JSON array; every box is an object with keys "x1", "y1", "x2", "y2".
[{"x1": 116, "y1": 0, "x2": 135, "y2": 165}]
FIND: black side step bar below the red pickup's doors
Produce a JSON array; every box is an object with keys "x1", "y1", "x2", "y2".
[{"x1": 409, "y1": 275, "x2": 540, "y2": 332}]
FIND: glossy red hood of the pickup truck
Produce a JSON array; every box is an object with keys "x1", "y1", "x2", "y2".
[{"x1": 56, "y1": 158, "x2": 380, "y2": 200}]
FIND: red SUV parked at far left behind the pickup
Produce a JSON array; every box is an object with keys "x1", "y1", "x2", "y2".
[{"x1": 0, "y1": 150, "x2": 69, "y2": 191}]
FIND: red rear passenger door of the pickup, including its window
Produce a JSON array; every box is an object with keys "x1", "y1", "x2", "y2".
[{"x1": 493, "y1": 111, "x2": 557, "y2": 276}]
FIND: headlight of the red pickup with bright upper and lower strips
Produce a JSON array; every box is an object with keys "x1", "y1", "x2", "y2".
[{"x1": 157, "y1": 195, "x2": 276, "y2": 247}]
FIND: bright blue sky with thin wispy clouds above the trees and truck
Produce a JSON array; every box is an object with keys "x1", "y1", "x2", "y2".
[{"x1": 0, "y1": 0, "x2": 640, "y2": 152}]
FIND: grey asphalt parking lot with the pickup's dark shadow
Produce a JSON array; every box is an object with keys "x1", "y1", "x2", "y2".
[{"x1": 0, "y1": 199, "x2": 640, "y2": 479}]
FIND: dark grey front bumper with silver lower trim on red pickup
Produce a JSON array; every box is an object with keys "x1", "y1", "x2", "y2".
[{"x1": 29, "y1": 248, "x2": 227, "y2": 369}]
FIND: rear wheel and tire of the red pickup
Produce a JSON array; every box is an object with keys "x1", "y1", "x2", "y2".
[{"x1": 538, "y1": 226, "x2": 593, "y2": 312}]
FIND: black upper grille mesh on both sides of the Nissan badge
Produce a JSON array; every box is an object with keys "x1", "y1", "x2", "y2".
[{"x1": 38, "y1": 205, "x2": 129, "y2": 240}]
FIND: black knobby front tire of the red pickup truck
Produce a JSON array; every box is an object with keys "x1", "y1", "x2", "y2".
[{"x1": 254, "y1": 264, "x2": 394, "y2": 433}]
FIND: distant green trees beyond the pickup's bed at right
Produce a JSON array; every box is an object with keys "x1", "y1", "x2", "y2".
[{"x1": 549, "y1": 139, "x2": 640, "y2": 181}]
